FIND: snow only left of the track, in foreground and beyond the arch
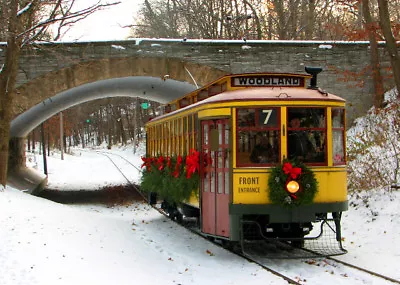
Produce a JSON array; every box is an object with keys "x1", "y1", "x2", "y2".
[{"x1": 0, "y1": 145, "x2": 286, "y2": 285}]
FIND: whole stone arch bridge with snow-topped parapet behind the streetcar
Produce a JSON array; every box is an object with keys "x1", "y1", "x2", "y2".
[{"x1": 0, "y1": 39, "x2": 389, "y2": 189}]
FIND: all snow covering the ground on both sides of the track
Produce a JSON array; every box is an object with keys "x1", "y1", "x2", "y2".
[{"x1": 0, "y1": 141, "x2": 400, "y2": 285}]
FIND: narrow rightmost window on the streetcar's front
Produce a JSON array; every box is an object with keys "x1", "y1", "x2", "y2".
[{"x1": 331, "y1": 108, "x2": 346, "y2": 165}]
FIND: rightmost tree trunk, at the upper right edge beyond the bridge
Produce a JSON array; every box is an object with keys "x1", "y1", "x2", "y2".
[{"x1": 378, "y1": 0, "x2": 400, "y2": 98}]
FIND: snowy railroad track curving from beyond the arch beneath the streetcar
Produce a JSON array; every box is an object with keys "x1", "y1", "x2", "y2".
[{"x1": 96, "y1": 151, "x2": 400, "y2": 285}]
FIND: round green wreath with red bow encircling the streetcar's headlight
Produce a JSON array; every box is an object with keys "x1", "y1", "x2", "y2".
[{"x1": 268, "y1": 160, "x2": 318, "y2": 206}]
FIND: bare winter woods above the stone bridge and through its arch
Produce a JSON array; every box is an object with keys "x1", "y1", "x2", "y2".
[{"x1": 0, "y1": 0, "x2": 400, "y2": 189}]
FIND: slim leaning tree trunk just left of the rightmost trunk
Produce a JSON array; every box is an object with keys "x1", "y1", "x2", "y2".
[{"x1": 362, "y1": 0, "x2": 384, "y2": 108}]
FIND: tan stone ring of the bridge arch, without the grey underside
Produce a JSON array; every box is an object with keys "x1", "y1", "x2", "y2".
[{"x1": 13, "y1": 57, "x2": 227, "y2": 116}]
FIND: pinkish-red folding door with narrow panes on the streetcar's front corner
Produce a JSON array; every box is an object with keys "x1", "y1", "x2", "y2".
[{"x1": 201, "y1": 119, "x2": 230, "y2": 237}]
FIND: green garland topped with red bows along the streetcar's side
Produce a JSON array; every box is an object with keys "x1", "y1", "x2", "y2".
[{"x1": 141, "y1": 149, "x2": 206, "y2": 204}]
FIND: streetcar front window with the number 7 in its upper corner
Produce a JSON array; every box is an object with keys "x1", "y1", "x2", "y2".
[{"x1": 236, "y1": 107, "x2": 280, "y2": 166}]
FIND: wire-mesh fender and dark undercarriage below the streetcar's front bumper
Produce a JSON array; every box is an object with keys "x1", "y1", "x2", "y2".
[{"x1": 240, "y1": 212, "x2": 347, "y2": 255}]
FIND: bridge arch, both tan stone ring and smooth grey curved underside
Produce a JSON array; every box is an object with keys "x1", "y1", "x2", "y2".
[{"x1": 11, "y1": 57, "x2": 226, "y2": 138}]
